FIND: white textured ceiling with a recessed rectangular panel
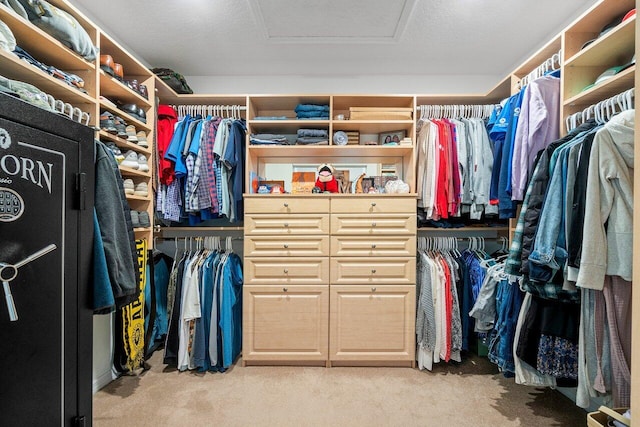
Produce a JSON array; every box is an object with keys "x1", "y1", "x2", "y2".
[{"x1": 71, "y1": 0, "x2": 593, "y2": 83}]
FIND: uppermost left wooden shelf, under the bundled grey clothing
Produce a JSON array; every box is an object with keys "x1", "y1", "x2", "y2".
[{"x1": 0, "y1": 3, "x2": 96, "y2": 72}]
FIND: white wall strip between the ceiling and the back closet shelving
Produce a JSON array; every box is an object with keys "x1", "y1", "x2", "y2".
[{"x1": 186, "y1": 72, "x2": 504, "y2": 95}]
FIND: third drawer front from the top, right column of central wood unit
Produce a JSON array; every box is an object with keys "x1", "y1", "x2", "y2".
[{"x1": 330, "y1": 236, "x2": 416, "y2": 256}]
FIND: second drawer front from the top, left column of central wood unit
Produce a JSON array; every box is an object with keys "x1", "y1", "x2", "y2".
[{"x1": 244, "y1": 214, "x2": 329, "y2": 236}]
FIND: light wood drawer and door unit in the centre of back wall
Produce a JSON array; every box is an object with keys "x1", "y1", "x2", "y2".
[{"x1": 243, "y1": 195, "x2": 416, "y2": 366}]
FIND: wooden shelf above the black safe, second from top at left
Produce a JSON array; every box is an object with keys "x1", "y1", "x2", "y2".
[{"x1": 0, "y1": 49, "x2": 96, "y2": 107}]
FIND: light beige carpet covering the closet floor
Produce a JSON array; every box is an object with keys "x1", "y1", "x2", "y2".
[{"x1": 93, "y1": 351, "x2": 586, "y2": 427}]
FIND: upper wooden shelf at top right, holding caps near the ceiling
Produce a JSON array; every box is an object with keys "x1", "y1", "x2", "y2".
[{"x1": 564, "y1": 17, "x2": 636, "y2": 69}]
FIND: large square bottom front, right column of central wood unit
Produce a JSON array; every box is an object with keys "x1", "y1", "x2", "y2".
[{"x1": 329, "y1": 286, "x2": 416, "y2": 361}]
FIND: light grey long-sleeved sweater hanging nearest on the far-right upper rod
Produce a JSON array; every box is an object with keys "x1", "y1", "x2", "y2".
[{"x1": 576, "y1": 110, "x2": 635, "y2": 290}]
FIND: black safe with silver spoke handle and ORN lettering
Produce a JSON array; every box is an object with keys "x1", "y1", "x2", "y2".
[{"x1": 0, "y1": 93, "x2": 95, "y2": 426}]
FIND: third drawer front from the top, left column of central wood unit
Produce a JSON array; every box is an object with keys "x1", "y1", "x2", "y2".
[{"x1": 244, "y1": 236, "x2": 329, "y2": 257}]
